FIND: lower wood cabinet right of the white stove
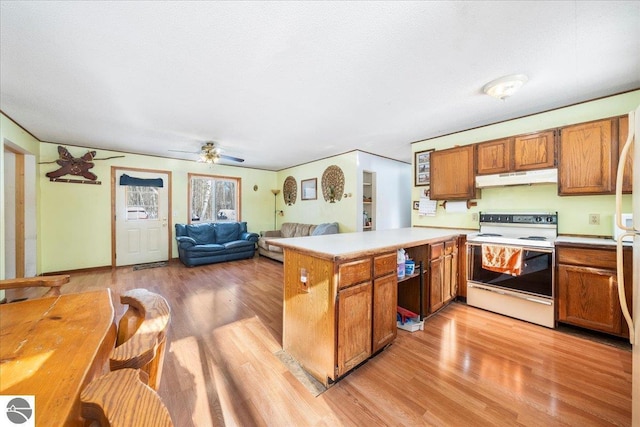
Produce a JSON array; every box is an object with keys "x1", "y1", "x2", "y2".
[{"x1": 556, "y1": 246, "x2": 632, "y2": 337}]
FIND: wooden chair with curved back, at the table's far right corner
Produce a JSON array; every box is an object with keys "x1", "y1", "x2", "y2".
[{"x1": 109, "y1": 289, "x2": 171, "y2": 390}]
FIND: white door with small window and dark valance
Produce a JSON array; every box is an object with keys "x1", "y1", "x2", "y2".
[{"x1": 115, "y1": 170, "x2": 169, "y2": 266}]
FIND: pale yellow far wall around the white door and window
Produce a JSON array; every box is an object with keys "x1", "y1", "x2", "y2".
[{"x1": 39, "y1": 143, "x2": 276, "y2": 272}]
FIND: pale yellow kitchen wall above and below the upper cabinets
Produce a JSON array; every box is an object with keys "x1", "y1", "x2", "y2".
[{"x1": 411, "y1": 90, "x2": 640, "y2": 236}]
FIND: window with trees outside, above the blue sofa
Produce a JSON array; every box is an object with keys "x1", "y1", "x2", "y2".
[{"x1": 189, "y1": 174, "x2": 240, "y2": 222}]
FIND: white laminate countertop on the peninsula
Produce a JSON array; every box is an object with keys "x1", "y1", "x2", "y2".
[{"x1": 267, "y1": 227, "x2": 476, "y2": 261}]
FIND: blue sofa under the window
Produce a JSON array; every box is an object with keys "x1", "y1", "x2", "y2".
[{"x1": 176, "y1": 222, "x2": 260, "y2": 267}]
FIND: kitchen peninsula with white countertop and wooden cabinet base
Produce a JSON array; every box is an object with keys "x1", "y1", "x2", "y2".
[{"x1": 269, "y1": 227, "x2": 468, "y2": 386}]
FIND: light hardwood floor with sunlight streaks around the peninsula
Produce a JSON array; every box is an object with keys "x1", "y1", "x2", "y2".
[{"x1": 41, "y1": 258, "x2": 631, "y2": 427}]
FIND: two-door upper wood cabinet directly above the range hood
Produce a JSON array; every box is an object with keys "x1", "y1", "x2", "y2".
[{"x1": 476, "y1": 130, "x2": 556, "y2": 175}]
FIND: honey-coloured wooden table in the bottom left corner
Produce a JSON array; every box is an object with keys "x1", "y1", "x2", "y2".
[{"x1": 0, "y1": 289, "x2": 116, "y2": 427}]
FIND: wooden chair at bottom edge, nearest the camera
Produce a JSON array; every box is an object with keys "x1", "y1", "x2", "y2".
[{"x1": 80, "y1": 369, "x2": 173, "y2": 427}]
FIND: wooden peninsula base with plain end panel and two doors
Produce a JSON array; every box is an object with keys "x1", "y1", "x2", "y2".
[{"x1": 282, "y1": 249, "x2": 398, "y2": 386}]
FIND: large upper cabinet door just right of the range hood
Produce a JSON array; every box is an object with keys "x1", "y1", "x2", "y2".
[{"x1": 558, "y1": 119, "x2": 617, "y2": 196}]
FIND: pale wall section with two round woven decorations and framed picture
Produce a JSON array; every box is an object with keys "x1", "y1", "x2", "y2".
[{"x1": 268, "y1": 151, "x2": 359, "y2": 233}]
